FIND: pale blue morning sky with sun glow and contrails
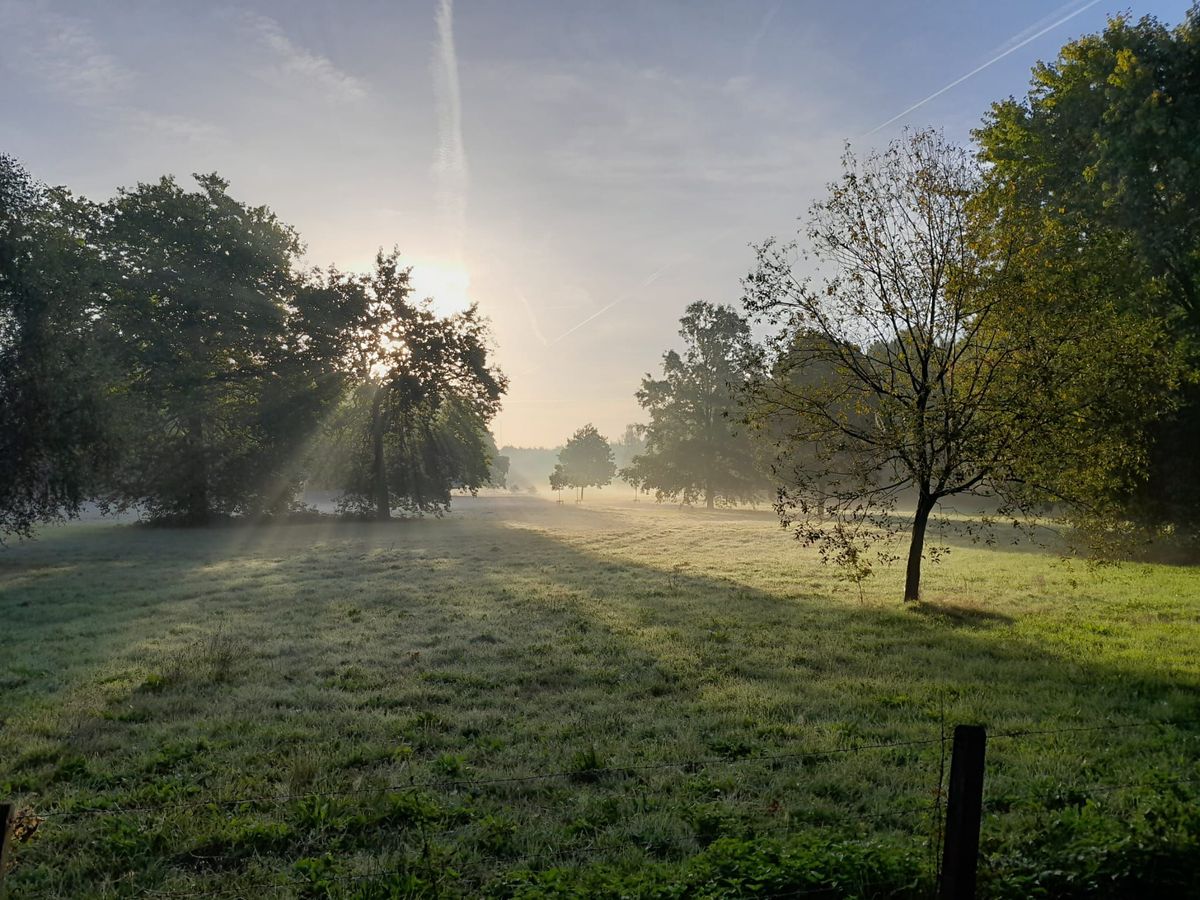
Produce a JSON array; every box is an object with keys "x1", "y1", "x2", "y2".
[{"x1": 0, "y1": 0, "x2": 1189, "y2": 446}]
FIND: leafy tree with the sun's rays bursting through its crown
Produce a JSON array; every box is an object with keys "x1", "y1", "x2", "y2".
[{"x1": 322, "y1": 251, "x2": 508, "y2": 520}]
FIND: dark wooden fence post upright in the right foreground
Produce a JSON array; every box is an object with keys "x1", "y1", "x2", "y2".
[{"x1": 938, "y1": 725, "x2": 988, "y2": 900}]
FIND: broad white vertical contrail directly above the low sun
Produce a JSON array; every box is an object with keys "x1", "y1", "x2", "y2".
[{"x1": 433, "y1": 0, "x2": 468, "y2": 258}]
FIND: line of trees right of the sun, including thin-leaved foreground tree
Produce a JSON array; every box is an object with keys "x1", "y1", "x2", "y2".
[{"x1": 552, "y1": 7, "x2": 1200, "y2": 600}]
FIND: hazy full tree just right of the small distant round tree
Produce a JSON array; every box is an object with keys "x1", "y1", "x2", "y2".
[{"x1": 625, "y1": 302, "x2": 766, "y2": 509}]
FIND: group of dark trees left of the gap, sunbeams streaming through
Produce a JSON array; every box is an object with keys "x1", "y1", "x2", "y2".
[{"x1": 0, "y1": 156, "x2": 506, "y2": 536}]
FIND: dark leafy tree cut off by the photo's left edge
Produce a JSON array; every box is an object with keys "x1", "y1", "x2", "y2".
[{"x1": 0, "y1": 155, "x2": 114, "y2": 538}]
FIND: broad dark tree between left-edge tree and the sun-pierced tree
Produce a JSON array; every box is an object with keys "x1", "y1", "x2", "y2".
[{"x1": 102, "y1": 175, "x2": 330, "y2": 523}]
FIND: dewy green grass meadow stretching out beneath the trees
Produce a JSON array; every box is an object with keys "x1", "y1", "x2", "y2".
[{"x1": 0, "y1": 497, "x2": 1200, "y2": 898}]
